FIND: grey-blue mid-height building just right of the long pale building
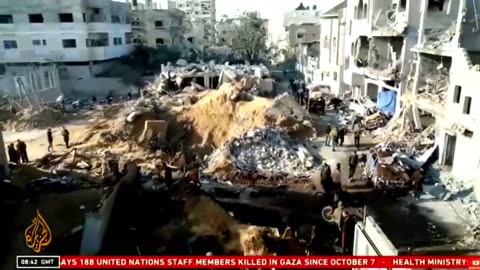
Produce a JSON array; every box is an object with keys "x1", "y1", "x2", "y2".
[{"x1": 132, "y1": 9, "x2": 185, "y2": 49}]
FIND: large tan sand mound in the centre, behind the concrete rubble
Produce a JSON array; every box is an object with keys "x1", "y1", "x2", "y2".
[{"x1": 178, "y1": 84, "x2": 312, "y2": 154}]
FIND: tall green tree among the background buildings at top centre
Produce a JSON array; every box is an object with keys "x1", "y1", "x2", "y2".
[{"x1": 232, "y1": 12, "x2": 268, "y2": 61}]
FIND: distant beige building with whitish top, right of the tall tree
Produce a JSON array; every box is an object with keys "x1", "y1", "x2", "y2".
[{"x1": 283, "y1": 3, "x2": 321, "y2": 48}]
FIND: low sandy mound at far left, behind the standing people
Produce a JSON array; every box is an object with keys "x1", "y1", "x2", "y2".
[{"x1": 5, "y1": 106, "x2": 67, "y2": 131}]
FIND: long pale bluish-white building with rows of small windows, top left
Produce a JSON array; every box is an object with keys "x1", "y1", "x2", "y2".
[{"x1": 0, "y1": 0, "x2": 131, "y2": 63}]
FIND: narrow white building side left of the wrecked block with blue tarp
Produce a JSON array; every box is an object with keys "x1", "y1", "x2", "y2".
[{"x1": 319, "y1": 1, "x2": 347, "y2": 95}]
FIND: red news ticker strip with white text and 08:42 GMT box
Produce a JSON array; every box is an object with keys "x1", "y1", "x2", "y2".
[{"x1": 17, "y1": 256, "x2": 480, "y2": 270}]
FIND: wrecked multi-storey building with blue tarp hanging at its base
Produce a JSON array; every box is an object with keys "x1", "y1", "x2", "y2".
[{"x1": 343, "y1": 0, "x2": 420, "y2": 114}]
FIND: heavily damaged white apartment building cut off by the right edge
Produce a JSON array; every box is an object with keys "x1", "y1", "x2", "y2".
[{"x1": 405, "y1": 0, "x2": 480, "y2": 182}]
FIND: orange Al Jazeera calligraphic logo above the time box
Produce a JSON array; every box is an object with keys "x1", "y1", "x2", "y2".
[{"x1": 25, "y1": 210, "x2": 52, "y2": 253}]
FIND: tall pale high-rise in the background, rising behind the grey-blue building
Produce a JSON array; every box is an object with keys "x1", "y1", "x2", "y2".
[{"x1": 175, "y1": 0, "x2": 216, "y2": 45}]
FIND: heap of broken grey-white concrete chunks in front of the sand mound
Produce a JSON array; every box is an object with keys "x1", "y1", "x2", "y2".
[{"x1": 208, "y1": 128, "x2": 315, "y2": 176}]
